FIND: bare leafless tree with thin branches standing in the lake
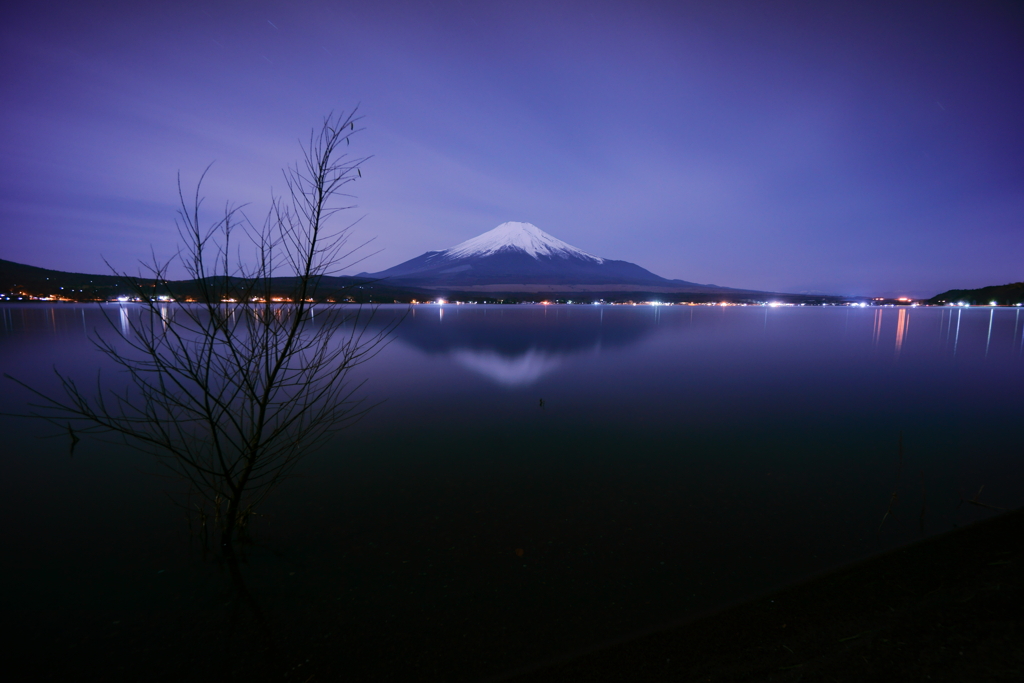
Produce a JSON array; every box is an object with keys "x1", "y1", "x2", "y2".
[{"x1": 8, "y1": 112, "x2": 392, "y2": 554}]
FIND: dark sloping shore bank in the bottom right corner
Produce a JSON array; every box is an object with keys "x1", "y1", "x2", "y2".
[{"x1": 501, "y1": 510, "x2": 1024, "y2": 683}]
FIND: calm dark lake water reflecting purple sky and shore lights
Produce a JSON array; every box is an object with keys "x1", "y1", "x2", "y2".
[{"x1": 0, "y1": 305, "x2": 1024, "y2": 680}]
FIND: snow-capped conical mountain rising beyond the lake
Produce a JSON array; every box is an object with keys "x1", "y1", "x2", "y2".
[{"x1": 362, "y1": 222, "x2": 690, "y2": 287}]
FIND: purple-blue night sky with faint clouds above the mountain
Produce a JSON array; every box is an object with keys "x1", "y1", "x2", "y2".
[{"x1": 0, "y1": 0, "x2": 1024, "y2": 296}]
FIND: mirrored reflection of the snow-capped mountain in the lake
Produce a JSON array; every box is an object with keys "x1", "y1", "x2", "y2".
[{"x1": 396, "y1": 306, "x2": 655, "y2": 386}]
